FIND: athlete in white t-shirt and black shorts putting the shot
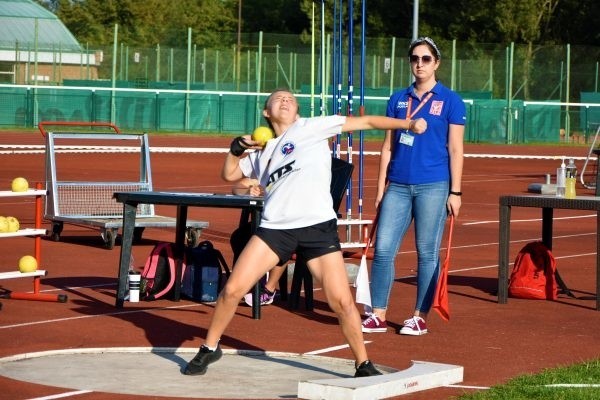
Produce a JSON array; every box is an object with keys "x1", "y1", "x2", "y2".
[{"x1": 183, "y1": 90, "x2": 427, "y2": 377}]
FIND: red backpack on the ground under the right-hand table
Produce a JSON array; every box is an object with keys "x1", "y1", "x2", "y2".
[{"x1": 508, "y1": 242, "x2": 558, "y2": 300}]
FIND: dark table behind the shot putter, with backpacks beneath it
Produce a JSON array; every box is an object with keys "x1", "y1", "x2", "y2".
[{"x1": 114, "y1": 192, "x2": 264, "y2": 319}]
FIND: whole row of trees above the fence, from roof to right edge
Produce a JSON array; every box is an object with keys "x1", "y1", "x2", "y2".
[{"x1": 37, "y1": 0, "x2": 600, "y2": 47}]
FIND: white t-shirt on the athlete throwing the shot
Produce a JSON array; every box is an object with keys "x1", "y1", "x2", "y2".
[{"x1": 240, "y1": 115, "x2": 346, "y2": 229}]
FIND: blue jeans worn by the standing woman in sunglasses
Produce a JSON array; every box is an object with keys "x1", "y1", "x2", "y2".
[{"x1": 370, "y1": 181, "x2": 449, "y2": 313}]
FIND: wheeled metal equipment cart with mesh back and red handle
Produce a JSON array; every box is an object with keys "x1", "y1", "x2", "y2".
[{"x1": 38, "y1": 122, "x2": 208, "y2": 249}]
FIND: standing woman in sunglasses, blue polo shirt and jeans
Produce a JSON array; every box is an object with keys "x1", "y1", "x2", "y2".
[{"x1": 362, "y1": 37, "x2": 466, "y2": 335}]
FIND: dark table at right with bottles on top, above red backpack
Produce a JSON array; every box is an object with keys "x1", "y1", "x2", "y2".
[{"x1": 498, "y1": 195, "x2": 600, "y2": 311}]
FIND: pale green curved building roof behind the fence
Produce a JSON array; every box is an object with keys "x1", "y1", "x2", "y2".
[{"x1": 0, "y1": 0, "x2": 81, "y2": 51}]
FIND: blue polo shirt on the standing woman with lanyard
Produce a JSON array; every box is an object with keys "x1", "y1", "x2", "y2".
[{"x1": 386, "y1": 82, "x2": 467, "y2": 185}]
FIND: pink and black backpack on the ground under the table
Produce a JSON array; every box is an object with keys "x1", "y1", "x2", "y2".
[{"x1": 140, "y1": 242, "x2": 186, "y2": 301}]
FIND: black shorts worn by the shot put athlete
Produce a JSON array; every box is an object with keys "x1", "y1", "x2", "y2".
[{"x1": 255, "y1": 219, "x2": 342, "y2": 263}]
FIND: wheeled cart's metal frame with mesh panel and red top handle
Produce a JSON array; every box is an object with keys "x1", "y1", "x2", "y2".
[{"x1": 38, "y1": 122, "x2": 208, "y2": 249}]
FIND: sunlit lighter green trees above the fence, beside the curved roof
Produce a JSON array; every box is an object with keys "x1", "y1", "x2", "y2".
[{"x1": 42, "y1": 0, "x2": 237, "y2": 48}]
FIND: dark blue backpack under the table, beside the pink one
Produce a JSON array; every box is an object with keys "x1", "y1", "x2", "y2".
[{"x1": 181, "y1": 240, "x2": 230, "y2": 303}]
